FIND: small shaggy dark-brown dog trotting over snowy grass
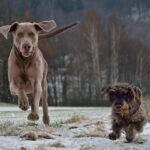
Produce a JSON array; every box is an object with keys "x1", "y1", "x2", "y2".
[{"x1": 102, "y1": 83, "x2": 148, "y2": 142}]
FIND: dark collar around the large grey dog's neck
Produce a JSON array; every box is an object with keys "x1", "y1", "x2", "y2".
[{"x1": 13, "y1": 46, "x2": 35, "y2": 62}]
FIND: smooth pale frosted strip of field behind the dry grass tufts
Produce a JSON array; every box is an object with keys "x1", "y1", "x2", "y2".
[{"x1": 0, "y1": 103, "x2": 110, "y2": 123}]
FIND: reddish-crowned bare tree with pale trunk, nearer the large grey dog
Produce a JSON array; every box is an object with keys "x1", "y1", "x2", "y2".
[{"x1": 82, "y1": 11, "x2": 102, "y2": 100}]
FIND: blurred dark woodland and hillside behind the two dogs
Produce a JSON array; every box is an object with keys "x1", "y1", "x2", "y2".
[{"x1": 0, "y1": 0, "x2": 150, "y2": 106}]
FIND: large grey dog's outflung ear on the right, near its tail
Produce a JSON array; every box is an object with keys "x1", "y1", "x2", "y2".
[{"x1": 34, "y1": 20, "x2": 56, "y2": 32}]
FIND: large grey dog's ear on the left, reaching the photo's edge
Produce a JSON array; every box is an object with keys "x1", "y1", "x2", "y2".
[{"x1": 0, "y1": 22, "x2": 19, "y2": 39}]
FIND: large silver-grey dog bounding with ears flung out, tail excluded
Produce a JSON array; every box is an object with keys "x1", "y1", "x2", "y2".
[{"x1": 0, "y1": 20, "x2": 56, "y2": 124}]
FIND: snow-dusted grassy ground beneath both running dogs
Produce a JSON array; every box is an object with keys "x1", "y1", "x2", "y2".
[{"x1": 0, "y1": 105, "x2": 150, "y2": 150}]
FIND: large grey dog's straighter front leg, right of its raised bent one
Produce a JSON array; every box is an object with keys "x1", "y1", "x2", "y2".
[{"x1": 28, "y1": 80, "x2": 42, "y2": 121}]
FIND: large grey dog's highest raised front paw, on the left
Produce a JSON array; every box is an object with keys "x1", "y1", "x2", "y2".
[{"x1": 18, "y1": 98, "x2": 29, "y2": 111}]
